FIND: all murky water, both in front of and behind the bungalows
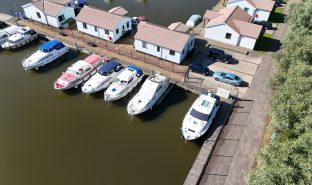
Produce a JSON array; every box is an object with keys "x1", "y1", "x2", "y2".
[{"x1": 0, "y1": 0, "x2": 221, "y2": 185}]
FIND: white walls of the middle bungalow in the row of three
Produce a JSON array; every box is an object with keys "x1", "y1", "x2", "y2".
[{"x1": 77, "y1": 17, "x2": 132, "y2": 42}]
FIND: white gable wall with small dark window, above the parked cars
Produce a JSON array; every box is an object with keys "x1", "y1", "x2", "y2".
[{"x1": 205, "y1": 24, "x2": 240, "y2": 46}]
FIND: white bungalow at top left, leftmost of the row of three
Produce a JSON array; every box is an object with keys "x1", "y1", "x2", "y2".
[{"x1": 22, "y1": 0, "x2": 75, "y2": 28}]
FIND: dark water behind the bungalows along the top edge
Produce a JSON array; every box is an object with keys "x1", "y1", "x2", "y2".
[{"x1": 0, "y1": 0, "x2": 219, "y2": 26}]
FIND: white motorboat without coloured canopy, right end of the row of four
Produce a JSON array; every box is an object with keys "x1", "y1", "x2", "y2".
[{"x1": 127, "y1": 73, "x2": 169, "y2": 115}]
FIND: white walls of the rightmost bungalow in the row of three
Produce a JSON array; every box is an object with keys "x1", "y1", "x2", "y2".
[{"x1": 134, "y1": 37, "x2": 195, "y2": 64}]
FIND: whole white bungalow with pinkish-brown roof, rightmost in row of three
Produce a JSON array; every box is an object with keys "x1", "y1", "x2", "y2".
[{"x1": 134, "y1": 22, "x2": 195, "y2": 64}]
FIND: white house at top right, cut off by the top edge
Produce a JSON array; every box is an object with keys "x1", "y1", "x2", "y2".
[{"x1": 227, "y1": 0, "x2": 275, "y2": 21}]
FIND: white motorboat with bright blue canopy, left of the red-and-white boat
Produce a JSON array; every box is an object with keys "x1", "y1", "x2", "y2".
[{"x1": 23, "y1": 40, "x2": 69, "y2": 70}]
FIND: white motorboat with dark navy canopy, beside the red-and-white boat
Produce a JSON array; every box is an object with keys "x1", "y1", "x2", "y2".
[{"x1": 81, "y1": 60, "x2": 124, "y2": 94}]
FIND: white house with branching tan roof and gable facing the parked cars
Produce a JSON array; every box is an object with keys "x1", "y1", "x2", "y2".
[{"x1": 204, "y1": 6, "x2": 262, "y2": 50}]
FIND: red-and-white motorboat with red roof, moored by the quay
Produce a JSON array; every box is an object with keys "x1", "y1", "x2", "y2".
[{"x1": 54, "y1": 54, "x2": 107, "y2": 90}]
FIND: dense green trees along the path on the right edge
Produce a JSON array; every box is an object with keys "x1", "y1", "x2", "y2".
[{"x1": 248, "y1": 0, "x2": 312, "y2": 185}]
